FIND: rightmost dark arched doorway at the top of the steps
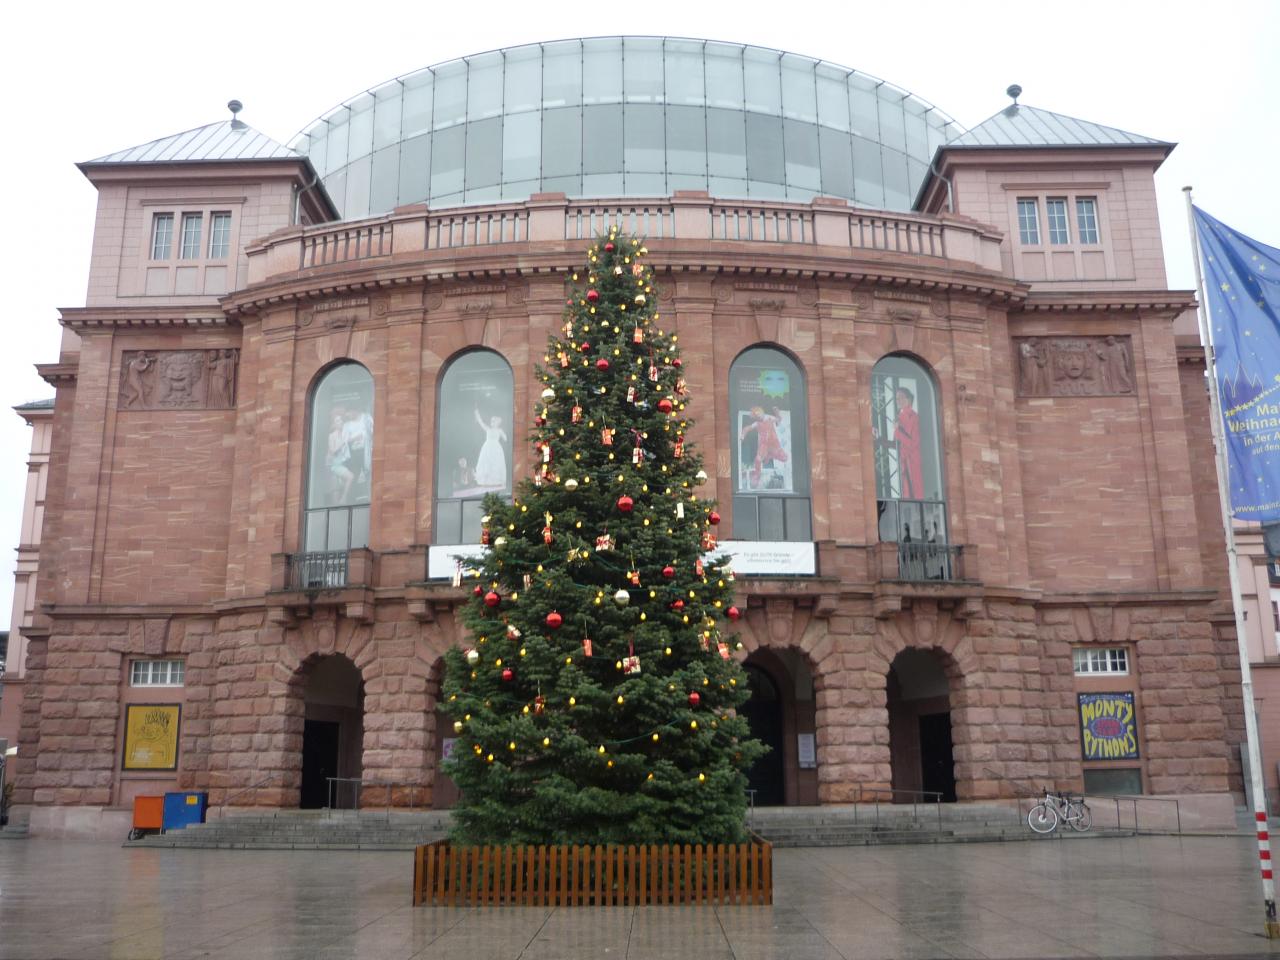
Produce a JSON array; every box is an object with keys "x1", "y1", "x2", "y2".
[{"x1": 886, "y1": 649, "x2": 956, "y2": 803}]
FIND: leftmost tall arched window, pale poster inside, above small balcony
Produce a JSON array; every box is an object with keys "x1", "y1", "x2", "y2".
[{"x1": 302, "y1": 361, "x2": 374, "y2": 553}]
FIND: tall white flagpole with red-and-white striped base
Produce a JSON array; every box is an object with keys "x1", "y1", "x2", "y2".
[{"x1": 1183, "y1": 187, "x2": 1280, "y2": 940}]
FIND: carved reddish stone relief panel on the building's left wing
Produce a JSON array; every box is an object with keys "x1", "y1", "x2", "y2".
[{"x1": 119, "y1": 349, "x2": 239, "y2": 410}]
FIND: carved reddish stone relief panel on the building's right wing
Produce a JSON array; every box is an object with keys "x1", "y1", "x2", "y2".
[{"x1": 1014, "y1": 335, "x2": 1134, "y2": 397}]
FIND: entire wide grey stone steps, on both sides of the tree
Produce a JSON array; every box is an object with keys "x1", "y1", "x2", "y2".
[{"x1": 125, "y1": 804, "x2": 1133, "y2": 850}]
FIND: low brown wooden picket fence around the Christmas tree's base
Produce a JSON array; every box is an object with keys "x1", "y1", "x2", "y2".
[{"x1": 413, "y1": 838, "x2": 773, "y2": 906}]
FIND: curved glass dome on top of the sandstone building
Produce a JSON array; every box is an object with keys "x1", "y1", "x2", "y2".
[{"x1": 292, "y1": 37, "x2": 959, "y2": 220}]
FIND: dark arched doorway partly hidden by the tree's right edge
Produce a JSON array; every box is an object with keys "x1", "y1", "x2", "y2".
[{"x1": 741, "y1": 648, "x2": 818, "y2": 806}]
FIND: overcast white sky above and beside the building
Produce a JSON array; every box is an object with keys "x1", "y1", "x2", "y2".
[{"x1": 0, "y1": 0, "x2": 1280, "y2": 628}]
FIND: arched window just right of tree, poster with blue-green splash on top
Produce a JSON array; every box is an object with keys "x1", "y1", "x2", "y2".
[{"x1": 728, "y1": 347, "x2": 813, "y2": 540}]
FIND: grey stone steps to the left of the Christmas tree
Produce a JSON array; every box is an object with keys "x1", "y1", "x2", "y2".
[{"x1": 124, "y1": 810, "x2": 449, "y2": 850}]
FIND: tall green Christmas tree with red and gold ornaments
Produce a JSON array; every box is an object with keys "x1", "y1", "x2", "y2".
[{"x1": 444, "y1": 232, "x2": 765, "y2": 844}]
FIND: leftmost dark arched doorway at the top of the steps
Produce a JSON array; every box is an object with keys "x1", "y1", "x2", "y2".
[{"x1": 298, "y1": 654, "x2": 365, "y2": 809}]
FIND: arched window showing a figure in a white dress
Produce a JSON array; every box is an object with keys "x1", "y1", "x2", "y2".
[{"x1": 435, "y1": 349, "x2": 515, "y2": 544}]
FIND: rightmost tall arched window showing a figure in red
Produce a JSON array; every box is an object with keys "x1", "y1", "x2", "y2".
[{"x1": 872, "y1": 355, "x2": 956, "y2": 580}]
